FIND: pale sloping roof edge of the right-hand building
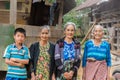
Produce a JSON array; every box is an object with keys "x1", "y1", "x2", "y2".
[{"x1": 75, "y1": 0, "x2": 101, "y2": 11}]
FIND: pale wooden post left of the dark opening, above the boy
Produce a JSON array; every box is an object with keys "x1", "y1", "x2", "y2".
[{"x1": 10, "y1": 0, "x2": 17, "y2": 24}]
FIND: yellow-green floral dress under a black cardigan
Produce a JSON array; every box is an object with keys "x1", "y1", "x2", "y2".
[{"x1": 36, "y1": 43, "x2": 50, "y2": 80}]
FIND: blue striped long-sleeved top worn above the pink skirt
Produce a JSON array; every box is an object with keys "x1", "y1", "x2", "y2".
[{"x1": 82, "y1": 40, "x2": 111, "y2": 67}]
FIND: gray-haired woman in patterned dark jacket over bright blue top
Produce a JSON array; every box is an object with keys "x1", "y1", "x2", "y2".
[{"x1": 55, "y1": 22, "x2": 80, "y2": 80}]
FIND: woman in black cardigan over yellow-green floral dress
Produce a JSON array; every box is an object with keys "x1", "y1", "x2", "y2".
[{"x1": 30, "y1": 26, "x2": 55, "y2": 80}]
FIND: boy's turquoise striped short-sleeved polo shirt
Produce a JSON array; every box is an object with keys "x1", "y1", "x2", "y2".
[{"x1": 3, "y1": 43, "x2": 30, "y2": 78}]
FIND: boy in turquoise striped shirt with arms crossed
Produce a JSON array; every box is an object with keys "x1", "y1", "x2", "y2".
[{"x1": 3, "y1": 28, "x2": 30, "y2": 80}]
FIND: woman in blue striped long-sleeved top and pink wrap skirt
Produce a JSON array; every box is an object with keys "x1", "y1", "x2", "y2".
[{"x1": 82, "y1": 25, "x2": 111, "y2": 80}]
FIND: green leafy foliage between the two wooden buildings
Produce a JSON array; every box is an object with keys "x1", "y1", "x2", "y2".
[{"x1": 63, "y1": 0, "x2": 90, "y2": 40}]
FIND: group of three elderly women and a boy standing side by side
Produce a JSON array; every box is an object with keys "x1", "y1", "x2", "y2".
[{"x1": 3, "y1": 22, "x2": 111, "y2": 80}]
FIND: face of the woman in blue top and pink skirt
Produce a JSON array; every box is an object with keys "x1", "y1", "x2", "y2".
[{"x1": 93, "y1": 26, "x2": 104, "y2": 40}]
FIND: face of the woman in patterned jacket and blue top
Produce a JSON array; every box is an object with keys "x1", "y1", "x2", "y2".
[{"x1": 65, "y1": 25, "x2": 75, "y2": 39}]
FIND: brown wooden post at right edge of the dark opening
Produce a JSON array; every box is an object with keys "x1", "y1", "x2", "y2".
[{"x1": 58, "y1": 0, "x2": 64, "y2": 28}]
